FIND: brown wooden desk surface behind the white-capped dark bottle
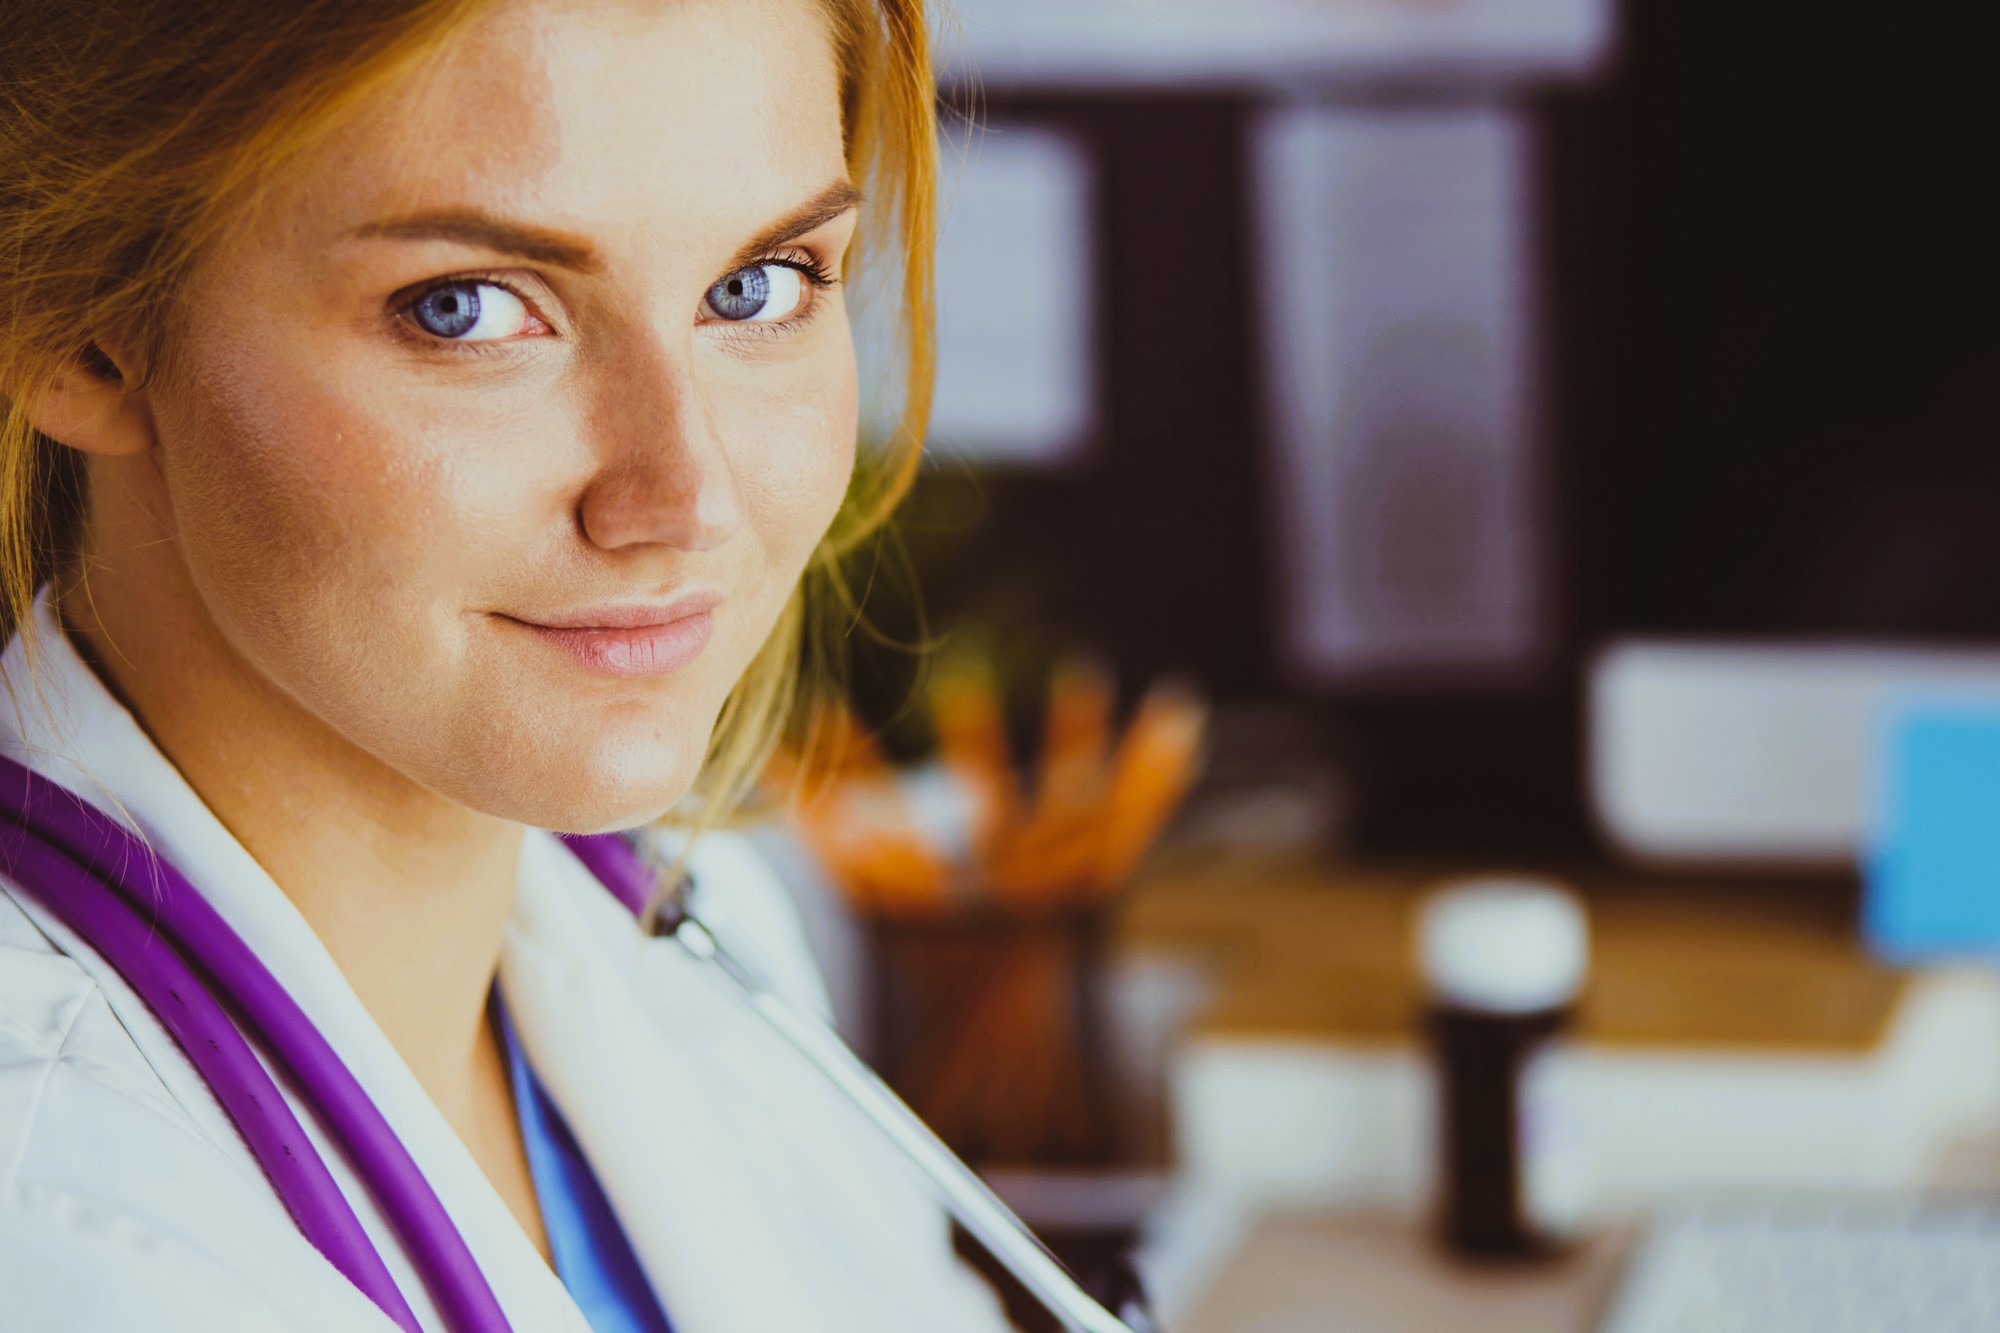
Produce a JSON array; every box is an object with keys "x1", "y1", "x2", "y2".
[{"x1": 1120, "y1": 853, "x2": 1908, "y2": 1053}]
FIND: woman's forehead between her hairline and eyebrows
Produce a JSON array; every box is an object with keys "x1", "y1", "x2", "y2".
[{"x1": 288, "y1": 0, "x2": 844, "y2": 248}]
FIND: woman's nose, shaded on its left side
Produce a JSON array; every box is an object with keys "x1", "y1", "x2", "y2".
[{"x1": 576, "y1": 346, "x2": 744, "y2": 550}]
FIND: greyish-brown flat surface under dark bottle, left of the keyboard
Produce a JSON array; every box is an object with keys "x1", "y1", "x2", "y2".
[{"x1": 1174, "y1": 1213, "x2": 1636, "y2": 1333}]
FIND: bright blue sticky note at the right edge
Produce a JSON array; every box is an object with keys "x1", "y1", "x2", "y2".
[{"x1": 1862, "y1": 701, "x2": 2000, "y2": 963}]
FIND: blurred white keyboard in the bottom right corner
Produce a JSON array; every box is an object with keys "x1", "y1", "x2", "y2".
[{"x1": 1602, "y1": 1197, "x2": 2000, "y2": 1333}]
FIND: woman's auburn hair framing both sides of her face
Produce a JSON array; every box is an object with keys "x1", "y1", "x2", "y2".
[{"x1": 0, "y1": 0, "x2": 936, "y2": 852}]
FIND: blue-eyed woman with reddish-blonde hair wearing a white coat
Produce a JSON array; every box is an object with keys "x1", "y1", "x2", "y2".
[{"x1": 0, "y1": 0, "x2": 1002, "y2": 1333}]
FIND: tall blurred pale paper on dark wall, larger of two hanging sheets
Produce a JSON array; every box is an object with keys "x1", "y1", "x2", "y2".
[{"x1": 1254, "y1": 106, "x2": 1550, "y2": 687}]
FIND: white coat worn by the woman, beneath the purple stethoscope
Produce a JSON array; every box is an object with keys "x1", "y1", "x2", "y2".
[{"x1": 0, "y1": 594, "x2": 1006, "y2": 1333}]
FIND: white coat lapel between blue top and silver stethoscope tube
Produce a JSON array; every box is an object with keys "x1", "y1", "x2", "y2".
[{"x1": 500, "y1": 835, "x2": 1006, "y2": 1333}]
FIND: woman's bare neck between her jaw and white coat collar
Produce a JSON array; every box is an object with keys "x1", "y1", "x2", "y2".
[{"x1": 60, "y1": 560, "x2": 522, "y2": 1125}]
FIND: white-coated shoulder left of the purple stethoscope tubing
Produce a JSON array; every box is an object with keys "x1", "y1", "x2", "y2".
[{"x1": 0, "y1": 881, "x2": 378, "y2": 1333}]
